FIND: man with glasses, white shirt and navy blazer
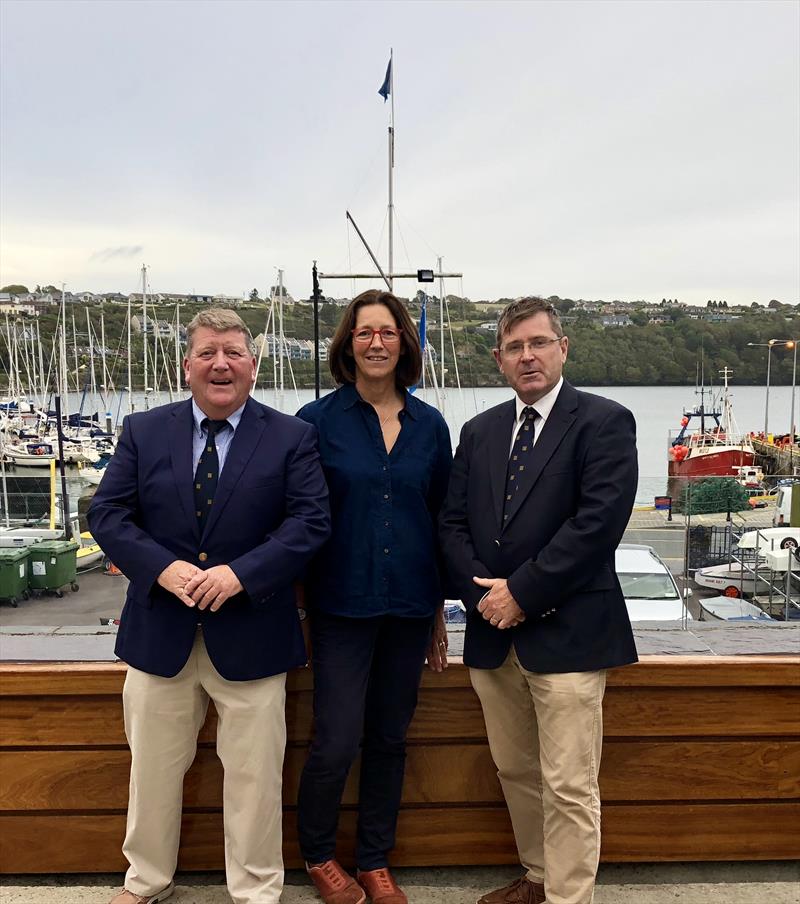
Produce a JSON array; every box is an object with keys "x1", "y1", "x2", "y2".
[{"x1": 440, "y1": 298, "x2": 637, "y2": 904}]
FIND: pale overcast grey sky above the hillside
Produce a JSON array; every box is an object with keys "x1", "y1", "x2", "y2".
[{"x1": 0, "y1": 0, "x2": 800, "y2": 305}]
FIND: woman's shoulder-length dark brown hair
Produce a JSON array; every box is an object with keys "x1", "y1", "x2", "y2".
[{"x1": 328, "y1": 289, "x2": 422, "y2": 389}]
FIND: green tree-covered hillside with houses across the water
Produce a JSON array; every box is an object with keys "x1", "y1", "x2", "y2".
[{"x1": 0, "y1": 287, "x2": 800, "y2": 389}]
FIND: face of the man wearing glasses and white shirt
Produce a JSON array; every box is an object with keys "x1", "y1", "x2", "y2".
[{"x1": 494, "y1": 311, "x2": 569, "y2": 405}]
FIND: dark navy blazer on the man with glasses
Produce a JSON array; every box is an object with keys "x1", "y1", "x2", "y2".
[{"x1": 439, "y1": 381, "x2": 637, "y2": 673}]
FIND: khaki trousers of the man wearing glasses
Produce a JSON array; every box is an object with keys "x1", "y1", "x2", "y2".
[{"x1": 470, "y1": 646, "x2": 606, "y2": 904}]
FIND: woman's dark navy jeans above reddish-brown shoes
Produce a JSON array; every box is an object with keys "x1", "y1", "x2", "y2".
[{"x1": 297, "y1": 612, "x2": 433, "y2": 870}]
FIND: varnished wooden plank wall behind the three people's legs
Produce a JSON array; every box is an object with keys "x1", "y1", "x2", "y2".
[{"x1": 0, "y1": 656, "x2": 800, "y2": 873}]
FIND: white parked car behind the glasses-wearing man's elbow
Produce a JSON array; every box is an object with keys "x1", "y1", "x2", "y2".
[{"x1": 615, "y1": 543, "x2": 692, "y2": 621}]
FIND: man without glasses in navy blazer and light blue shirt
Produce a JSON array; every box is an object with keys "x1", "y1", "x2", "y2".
[{"x1": 88, "y1": 309, "x2": 330, "y2": 904}]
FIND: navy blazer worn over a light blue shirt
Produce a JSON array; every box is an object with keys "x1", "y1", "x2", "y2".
[{"x1": 87, "y1": 398, "x2": 330, "y2": 681}]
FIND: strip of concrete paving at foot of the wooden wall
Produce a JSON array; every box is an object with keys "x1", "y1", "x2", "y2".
[{"x1": 0, "y1": 862, "x2": 800, "y2": 904}]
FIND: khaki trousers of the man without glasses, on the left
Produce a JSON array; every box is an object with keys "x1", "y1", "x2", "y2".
[{"x1": 122, "y1": 630, "x2": 286, "y2": 904}]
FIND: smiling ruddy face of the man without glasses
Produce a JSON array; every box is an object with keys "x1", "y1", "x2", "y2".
[{"x1": 183, "y1": 326, "x2": 256, "y2": 420}]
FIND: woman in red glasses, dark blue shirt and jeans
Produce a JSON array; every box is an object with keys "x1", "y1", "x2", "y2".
[{"x1": 297, "y1": 290, "x2": 452, "y2": 904}]
